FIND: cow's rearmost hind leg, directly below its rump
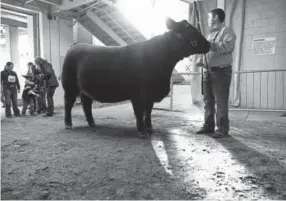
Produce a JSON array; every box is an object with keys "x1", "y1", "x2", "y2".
[{"x1": 64, "y1": 92, "x2": 78, "y2": 129}]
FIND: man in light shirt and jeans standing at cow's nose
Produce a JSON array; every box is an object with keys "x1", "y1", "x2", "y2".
[{"x1": 196, "y1": 8, "x2": 236, "y2": 138}]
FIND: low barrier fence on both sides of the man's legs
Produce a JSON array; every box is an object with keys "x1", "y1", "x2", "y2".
[{"x1": 154, "y1": 70, "x2": 286, "y2": 112}]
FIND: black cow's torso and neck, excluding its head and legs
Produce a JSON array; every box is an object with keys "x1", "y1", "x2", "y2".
[{"x1": 62, "y1": 35, "x2": 180, "y2": 102}]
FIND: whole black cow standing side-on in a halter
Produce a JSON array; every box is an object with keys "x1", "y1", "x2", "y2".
[{"x1": 62, "y1": 18, "x2": 210, "y2": 136}]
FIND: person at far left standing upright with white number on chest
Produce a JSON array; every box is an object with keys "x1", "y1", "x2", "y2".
[{"x1": 1, "y1": 62, "x2": 21, "y2": 118}]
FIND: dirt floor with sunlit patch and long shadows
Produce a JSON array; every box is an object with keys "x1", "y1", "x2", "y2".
[{"x1": 1, "y1": 104, "x2": 286, "y2": 200}]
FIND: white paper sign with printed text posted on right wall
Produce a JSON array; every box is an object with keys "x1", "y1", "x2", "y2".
[{"x1": 252, "y1": 37, "x2": 276, "y2": 55}]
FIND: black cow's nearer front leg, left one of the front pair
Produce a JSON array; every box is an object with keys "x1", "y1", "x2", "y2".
[{"x1": 131, "y1": 99, "x2": 149, "y2": 137}]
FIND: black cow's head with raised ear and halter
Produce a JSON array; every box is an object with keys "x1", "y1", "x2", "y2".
[{"x1": 166, "y1": 18, "x2": 210, "y2": 56}]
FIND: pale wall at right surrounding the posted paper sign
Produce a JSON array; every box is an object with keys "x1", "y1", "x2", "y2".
[{"x1": 241, "y1": 0, "x2": 286, "y2": 109}]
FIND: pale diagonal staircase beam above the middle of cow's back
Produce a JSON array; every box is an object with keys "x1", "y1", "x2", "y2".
[{"x1": 86, "y1": 11, "x2": 127, "y2": 45}]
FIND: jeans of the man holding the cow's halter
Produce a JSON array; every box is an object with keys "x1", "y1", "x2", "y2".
[{"x1": 203, "y1": 66, "x2": 232, "y2": 133}]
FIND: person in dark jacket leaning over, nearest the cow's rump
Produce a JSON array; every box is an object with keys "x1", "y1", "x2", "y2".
[{"x1": 35, "y1": 57, "x2": 59, "y2": 117}]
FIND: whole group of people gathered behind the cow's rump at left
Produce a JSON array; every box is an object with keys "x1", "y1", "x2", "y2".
[{"x1": 1, "y1": 57, "x2": 59, "y2": 118}]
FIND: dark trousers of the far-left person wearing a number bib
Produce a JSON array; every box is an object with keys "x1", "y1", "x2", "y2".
[{"x1": 3, "y1": 86, "x2": 20, "y2": 116}]
